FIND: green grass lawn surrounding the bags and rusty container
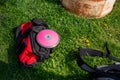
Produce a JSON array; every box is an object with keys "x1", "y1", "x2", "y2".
[{"x1": 0, "y1": 0, "x2": 120, "y2": 80}]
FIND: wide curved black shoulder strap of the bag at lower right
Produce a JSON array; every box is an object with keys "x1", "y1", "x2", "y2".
[{"x1": 77, "y1": 48, "x2": 103, "y2": 73}]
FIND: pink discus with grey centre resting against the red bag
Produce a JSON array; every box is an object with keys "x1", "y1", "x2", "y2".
[{"x1": 36, "y1": 29, "x2": 59, "y2": 48}]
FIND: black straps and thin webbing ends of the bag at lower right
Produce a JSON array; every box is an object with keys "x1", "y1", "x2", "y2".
[{"x1": 77, "y1": 44, "x2": 120, "y2": 73}]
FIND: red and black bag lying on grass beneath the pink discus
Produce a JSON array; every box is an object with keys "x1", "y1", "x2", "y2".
[{"x1": 16, "y1": 19, "x2": 52, "y2": 67}]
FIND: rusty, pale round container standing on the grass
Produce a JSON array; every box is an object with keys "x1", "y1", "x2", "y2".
[{"x1": 61, "y1": 0, "x2": 115, "y2": 18}]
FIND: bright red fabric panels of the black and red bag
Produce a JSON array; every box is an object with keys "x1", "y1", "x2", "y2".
[{"x1": 19, "y1": 22, "x2": 38, "y2": 65}]
